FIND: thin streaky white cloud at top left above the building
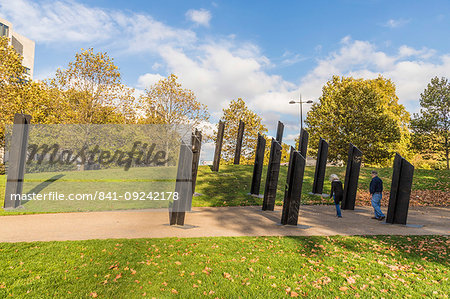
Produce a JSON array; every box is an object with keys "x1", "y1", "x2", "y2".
[{"x1": 0, "y1": 0, "x2": 196, "y2": 51}]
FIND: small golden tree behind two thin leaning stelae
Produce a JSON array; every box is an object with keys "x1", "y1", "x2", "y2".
[{"x1": 220, "y1": 98, "x2": 270, "y2": 164}]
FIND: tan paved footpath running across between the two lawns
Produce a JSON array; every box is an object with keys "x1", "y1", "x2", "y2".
[{"x1": 0, "y1": 206, "x2": 450, "y2": 242}]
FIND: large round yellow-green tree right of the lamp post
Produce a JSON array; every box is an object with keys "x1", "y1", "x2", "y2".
[{"x1": 306, "y1": 76, "x2": 410, "y2": 165}]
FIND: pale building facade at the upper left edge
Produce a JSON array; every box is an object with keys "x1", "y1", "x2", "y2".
[{"x1": 0, "y1": 18, "x2": 35, "y2": 79}]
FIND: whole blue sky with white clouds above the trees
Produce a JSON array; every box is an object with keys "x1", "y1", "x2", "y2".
[{"x1": 0, "y1": 0, "x2": 450, "y2": 159}]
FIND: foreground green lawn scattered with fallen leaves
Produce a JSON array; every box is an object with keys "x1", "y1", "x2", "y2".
[{"x1": 0, "y1": 236, "x2": 450, "y2": 298}]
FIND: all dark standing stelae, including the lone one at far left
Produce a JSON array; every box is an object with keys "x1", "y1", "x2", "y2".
[{"x1": 4, "y1": 114, "x2": 414, "y2": 225}]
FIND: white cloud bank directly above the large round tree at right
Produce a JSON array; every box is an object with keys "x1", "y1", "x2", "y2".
[{"x1": 299, "y1": 37, "x2": 450, "y2": 111}]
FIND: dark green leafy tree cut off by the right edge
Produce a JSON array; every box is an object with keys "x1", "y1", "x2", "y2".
[{"x1": 411, "y1": 77, "x2": 450, "y2": 169}]
